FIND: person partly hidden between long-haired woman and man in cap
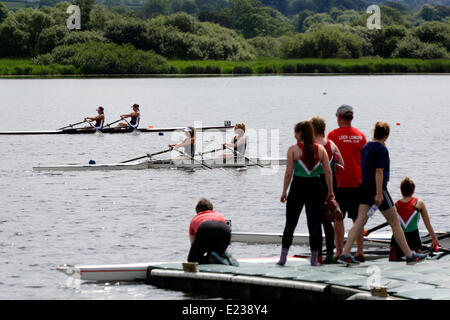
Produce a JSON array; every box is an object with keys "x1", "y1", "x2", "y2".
[{"x1": 310, "y1": 117, "x2": 344, "y2": 264}]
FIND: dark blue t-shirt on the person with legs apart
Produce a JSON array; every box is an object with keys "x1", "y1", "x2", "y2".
[{"x1": 361, "y1": 142, "x2": 391, "y2": 185}]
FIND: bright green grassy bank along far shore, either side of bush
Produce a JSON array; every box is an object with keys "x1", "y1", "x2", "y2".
[{"x1": 0, "y1": 58, "x2": 450, "y2": 76}]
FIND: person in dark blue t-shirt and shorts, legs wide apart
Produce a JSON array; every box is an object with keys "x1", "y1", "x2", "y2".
[{"x1": 338, "y1": 121, "x2": 426, "y2": 265}]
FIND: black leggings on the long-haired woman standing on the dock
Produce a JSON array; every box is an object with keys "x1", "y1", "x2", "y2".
[{"x1": 282, "y1": 176, "x2": 323, "y2": 250}]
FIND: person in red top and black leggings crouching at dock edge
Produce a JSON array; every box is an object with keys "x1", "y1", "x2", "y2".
[{"x1": 188, "y1": 199, "x2": 231, "y2": 263}]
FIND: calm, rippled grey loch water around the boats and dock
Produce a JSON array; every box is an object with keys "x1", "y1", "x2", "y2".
[{"x1": 0, "y1": 75, "x2": 450, "y2": 299}]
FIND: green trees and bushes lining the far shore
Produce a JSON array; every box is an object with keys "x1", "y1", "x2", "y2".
[{"x1": 0, "y1": 0, "x2": 450, "y2": 73}]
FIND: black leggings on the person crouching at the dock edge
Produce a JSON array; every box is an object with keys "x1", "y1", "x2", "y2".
[{"x1": 188, "y1": 221, "x2": 231, "y2": 263}]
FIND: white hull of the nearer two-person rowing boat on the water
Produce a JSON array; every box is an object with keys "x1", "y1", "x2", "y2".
[{"x1": 33, "y1": 158, "x2": 286, "y2": 171}]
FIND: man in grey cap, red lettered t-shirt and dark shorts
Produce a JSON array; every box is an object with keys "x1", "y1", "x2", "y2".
[{"x1": 328, "y1": 104, "x2": 367, "y2": 261}]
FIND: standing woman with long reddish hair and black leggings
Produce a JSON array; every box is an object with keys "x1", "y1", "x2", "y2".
[{"x1": 278, "y1": 121, "x2": 334, "y2": 266}]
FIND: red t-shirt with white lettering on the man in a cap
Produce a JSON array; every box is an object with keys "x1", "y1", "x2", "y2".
[{"x1": 328, "y1": 127, "x2": 367, "y2": 188}]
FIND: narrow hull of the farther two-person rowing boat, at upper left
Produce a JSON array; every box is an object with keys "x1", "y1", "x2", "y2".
[{"x1": 0, "y1": 125, "x2": 233, "y2": 135}]
